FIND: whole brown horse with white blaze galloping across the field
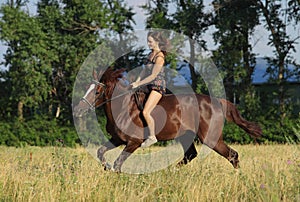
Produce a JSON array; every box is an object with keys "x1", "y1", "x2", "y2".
[{"x1": 74, "y1": 68, "x2": 262, "y2": 172}]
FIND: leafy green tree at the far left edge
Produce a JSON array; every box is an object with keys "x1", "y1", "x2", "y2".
[{"x1": 0, "y1": 1, "x2": 51, "y2": 120}]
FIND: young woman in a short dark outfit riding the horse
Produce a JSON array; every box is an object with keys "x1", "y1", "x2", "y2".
[{"x1": 131, "y1": 32, "x2": 169, "y2": 147}]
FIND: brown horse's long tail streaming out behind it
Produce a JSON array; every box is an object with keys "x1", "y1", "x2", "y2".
[{"x1": 220, "y1": 99, "x2": 262, "y2": 138}]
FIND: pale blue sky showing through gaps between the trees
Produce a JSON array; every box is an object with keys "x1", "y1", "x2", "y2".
[{"x1": 0, "y1": 0, "x2": 300, "y2": 68}]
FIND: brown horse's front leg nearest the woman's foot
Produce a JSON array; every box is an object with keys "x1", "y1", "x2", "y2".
[{"x1": 114, "y1": 140, "x2": 143, "y2": 172}]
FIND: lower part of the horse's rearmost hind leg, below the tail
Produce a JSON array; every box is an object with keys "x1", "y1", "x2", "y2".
[{"x1": 213, "y1": 140, "x2": 239, "y2": 168}]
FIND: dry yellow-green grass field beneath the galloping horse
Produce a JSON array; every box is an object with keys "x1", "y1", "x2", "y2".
[{"x1": 0, "y1": 145, "x2": 300, "y2": 202}]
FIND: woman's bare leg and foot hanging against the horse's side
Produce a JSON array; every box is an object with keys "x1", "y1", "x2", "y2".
[{"x1": 141, "y1": 90, "x2": 162, "y2": 147}]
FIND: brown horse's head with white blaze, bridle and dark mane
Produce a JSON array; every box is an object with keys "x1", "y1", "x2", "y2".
[{"x1": 74, "y1": 68, "x2": 124, "y2": 117}]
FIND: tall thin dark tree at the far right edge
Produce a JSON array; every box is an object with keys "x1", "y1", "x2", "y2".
[{"x1": 257, "y1": 0, "x2": 300, "y2": 125}]
